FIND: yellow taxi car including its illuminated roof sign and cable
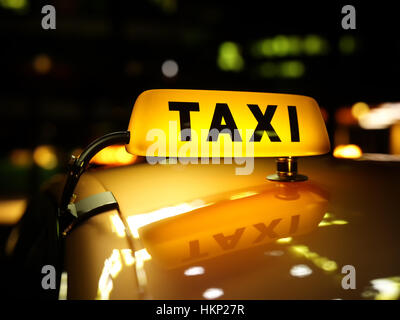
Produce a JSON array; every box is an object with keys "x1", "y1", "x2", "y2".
[{"x1": 3, "y1": 90, "x2": 400, "y2": 300}]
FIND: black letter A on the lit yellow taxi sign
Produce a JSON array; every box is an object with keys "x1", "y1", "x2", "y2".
[{"x1": 207, "y1": 103, "x2": 242, "y2": 141}]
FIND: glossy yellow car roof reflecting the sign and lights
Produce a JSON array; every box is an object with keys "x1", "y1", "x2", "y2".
[{"x1": 66, "y1": 156, "x2": 400, "y2": 299}]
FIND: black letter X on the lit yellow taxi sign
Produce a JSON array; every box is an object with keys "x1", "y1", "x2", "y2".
[{"x1": 248, "y1": 104, "x2": 281, "y2": 142}]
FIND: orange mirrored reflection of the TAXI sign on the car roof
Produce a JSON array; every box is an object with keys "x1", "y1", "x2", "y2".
[{"x1": 138, "y1": 182, "x2": 329, "y2": 269}]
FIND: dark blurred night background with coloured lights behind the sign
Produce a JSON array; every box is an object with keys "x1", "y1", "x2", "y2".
[{"x1": 0, "y1": 0, "x2": 400, "y2": 199}]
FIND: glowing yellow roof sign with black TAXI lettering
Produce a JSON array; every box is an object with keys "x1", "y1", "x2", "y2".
[{"x1": 127, "y1": 89, "x2": 330, "y2": 157}]
